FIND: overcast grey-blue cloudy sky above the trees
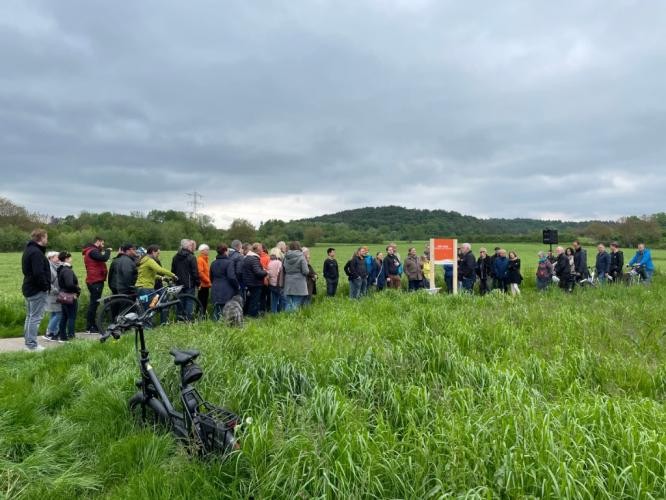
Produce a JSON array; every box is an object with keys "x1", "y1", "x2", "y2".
[{"x1": 0, "y1": 0, "x2": 666, "y2": 227}]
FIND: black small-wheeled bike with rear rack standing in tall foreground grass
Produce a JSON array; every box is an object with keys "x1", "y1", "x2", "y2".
[{"x1": 100, "y1": 300, "x2": 240, "y2": 456}]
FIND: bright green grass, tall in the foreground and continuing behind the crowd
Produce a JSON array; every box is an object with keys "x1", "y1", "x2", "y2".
[{"x1": 0, "y1": 244, "x2": 666, "y2": 499}]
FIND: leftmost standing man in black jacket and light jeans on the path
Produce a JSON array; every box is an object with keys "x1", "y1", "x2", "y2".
[{"x1": 21, "y1": 229, "x2": 51, "y2": 352}]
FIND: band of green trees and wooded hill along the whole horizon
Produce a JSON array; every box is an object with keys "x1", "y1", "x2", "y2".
[{"x1": 0, "y1": 197, "x2": 666, "y2": 252}]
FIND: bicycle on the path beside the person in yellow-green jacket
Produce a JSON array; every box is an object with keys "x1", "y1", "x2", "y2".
[{"x1": 97, "y1": 278, "x2": 203, "y2": 332}]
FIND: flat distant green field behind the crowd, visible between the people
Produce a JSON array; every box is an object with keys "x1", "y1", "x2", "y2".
[{"x1": 0, "y1": 241, "x2": 666, "y2": 338}]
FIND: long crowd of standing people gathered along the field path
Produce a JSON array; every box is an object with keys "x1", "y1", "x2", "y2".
[{"x1": 22, "y1": 229, "x2": 654, "y2": 351}]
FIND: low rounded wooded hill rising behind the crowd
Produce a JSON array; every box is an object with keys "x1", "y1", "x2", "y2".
[{"x1": 262, "y1": 206, "x2": 590, "y2": 242}]
